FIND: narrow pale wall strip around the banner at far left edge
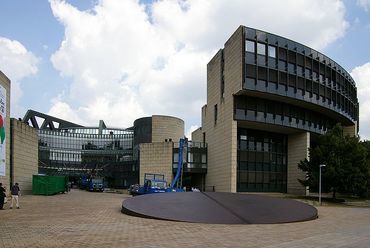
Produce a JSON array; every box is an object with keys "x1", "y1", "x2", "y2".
[{"x1": 0, "y1": 71, "x2": 10, "y2": 189}]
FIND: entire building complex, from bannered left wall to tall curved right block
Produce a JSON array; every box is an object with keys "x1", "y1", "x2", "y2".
[{"x1": 0, "y1": 26, "x2": 359, "y2": 194}]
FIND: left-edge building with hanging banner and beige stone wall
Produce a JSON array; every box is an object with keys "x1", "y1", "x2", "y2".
[{"x1": 0, "y1": 71, "x2": 38, "y2": 193}]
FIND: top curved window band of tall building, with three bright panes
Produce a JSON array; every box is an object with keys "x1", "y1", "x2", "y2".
[{"x1": 243, "y1": 28, "x2": 358, "y2": 125}]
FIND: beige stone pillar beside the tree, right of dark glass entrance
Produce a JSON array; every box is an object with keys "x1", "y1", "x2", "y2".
[{"x1": 287, "y1": 132, "x2": 310, "y2": 195}]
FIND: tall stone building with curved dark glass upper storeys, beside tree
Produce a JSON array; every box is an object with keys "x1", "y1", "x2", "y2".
[{"x1": 192, "y1": 26, "x2": 359, "y2": 194}]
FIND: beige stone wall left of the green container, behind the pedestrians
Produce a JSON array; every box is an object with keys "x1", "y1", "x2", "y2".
[{"x1": 11, "y1": 119, "x2": 39, "y2": 194}]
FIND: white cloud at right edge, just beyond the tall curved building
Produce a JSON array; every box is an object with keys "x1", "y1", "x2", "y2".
[{"x1": 351, "y1": 62, "x2": 370, "y2": 139}]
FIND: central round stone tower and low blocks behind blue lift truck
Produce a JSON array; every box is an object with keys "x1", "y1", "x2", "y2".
[{"x1": 133, "y1": 115, "x2": 207, "y2": 189}]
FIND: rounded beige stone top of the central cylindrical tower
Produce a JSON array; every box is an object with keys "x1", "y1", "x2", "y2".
[{"x1": 152, "y1": 115, "x2": 184, "y2": 143}]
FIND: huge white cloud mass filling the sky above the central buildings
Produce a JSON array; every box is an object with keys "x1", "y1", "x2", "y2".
[{"x1": 50, "y1": 0, "x2": 348, "y2": 135}]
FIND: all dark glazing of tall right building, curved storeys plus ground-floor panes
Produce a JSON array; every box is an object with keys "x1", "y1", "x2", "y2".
[{"x1": 233, "y1": 27, "x2": 358, "y2": 192}]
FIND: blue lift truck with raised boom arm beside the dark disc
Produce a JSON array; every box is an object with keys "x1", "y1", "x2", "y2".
[{"x1": 129, "y1": 138, "x2": 185, "y2": 196}]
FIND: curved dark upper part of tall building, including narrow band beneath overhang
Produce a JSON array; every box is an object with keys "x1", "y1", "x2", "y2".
[{"x1": 240, "y1": 27, "x2": 358, "y2": 133}]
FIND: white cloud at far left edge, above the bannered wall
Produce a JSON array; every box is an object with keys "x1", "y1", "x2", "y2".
[{"x1": 0, "y1": 37, "x2": 39, "y2": 116}]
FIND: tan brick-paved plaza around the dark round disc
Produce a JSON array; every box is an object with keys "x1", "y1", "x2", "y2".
[{"x1": 0, "y1": 190, "x2": 370, "y2": 248}]
